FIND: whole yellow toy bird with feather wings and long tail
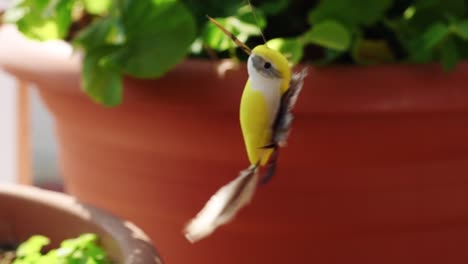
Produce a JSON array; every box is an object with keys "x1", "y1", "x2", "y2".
[{"x1": 185, "y1": 17, "x2": 307, "y2": 242}]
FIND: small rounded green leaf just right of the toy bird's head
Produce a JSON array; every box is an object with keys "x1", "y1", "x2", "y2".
[{"x1": 304, "y1": 20, "x2": 351, "y2": 51}]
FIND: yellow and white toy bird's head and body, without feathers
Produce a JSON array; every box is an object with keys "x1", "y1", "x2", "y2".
[{"x1": 240, "y1": 45, "x2": 291, "y2": 165}]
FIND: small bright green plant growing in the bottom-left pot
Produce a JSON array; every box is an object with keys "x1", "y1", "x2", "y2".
[{"x1": 9, "y1": 234, "x2": 110, "y2": 264}]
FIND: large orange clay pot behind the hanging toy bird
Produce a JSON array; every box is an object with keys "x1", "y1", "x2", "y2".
[{"x1": 0, "y1": 25, "x2": 468, "y2": 264}]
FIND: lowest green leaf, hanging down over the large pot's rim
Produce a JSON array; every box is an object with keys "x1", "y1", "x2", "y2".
[{"x1": 82, "y1": 47, "x2": 122, "y2": 105}]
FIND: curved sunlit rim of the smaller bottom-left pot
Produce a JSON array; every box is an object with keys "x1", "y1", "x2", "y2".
[{"x1": 0, "y1": 184, "x2": 162, "y2": 264}]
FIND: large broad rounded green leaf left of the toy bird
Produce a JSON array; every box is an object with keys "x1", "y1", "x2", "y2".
[{"x1": 107, "y1": 0, "x2": 196, "y2": 78}]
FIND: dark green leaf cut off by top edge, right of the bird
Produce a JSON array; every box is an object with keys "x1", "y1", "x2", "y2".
[{"x1": 308, "y1": 0, "x2": 392, "y2": 26}]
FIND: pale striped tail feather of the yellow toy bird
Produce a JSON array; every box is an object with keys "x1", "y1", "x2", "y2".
[{"x1": 184, "y1": 165, "x2": 258, "y2": 243}]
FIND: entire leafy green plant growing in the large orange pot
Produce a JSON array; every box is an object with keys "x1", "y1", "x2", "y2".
[{"x1": 5, "y1": 0, "x2": 468, "y2": 106}]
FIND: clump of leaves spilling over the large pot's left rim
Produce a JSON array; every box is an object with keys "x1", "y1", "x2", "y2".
[{"x1": 5, "y1": 0, "x2": 196, "y2": 106}]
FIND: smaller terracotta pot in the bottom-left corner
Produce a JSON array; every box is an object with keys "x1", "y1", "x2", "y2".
[{"x1": 0, "y1": 185, "x2": 162, "y2": 264}]
